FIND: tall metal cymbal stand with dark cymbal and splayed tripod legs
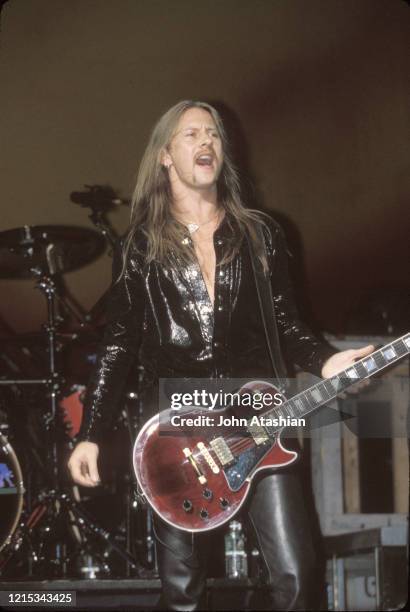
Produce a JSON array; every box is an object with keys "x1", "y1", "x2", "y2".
[{"x1": 0, "y1": 226, "x2": 141, "y2": 576}]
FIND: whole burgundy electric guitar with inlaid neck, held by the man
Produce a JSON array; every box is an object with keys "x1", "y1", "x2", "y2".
[{"x1": 133, "y1": 333, "x2": 410, "y2": 532}]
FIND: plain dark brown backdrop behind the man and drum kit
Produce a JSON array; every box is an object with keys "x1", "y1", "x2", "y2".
[{"x1": 0, "y1": 0, "x2": 410, "y2": 331}]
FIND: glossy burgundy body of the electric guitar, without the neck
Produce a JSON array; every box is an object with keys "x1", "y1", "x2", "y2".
[{"x1": 133, "y1": 387, "x2": 297, "y2": 532}]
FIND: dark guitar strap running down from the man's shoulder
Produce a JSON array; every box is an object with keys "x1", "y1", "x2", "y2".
[{"x1": 247, "y1": 223, "x2": 287, "y2": 391}]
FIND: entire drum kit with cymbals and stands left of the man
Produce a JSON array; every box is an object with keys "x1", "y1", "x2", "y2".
[{"x1": 0, "y1": 186, "x2": 156, "y2": 578}]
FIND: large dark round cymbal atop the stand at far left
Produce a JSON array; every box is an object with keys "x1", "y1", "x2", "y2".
[{"x1": 0, "y1": 225, "x2": 106, "y2": 279}]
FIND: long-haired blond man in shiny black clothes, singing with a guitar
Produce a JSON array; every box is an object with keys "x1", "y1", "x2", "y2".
[{"x1": 69, "y1": 101, "x2": 372, "y2": 610}]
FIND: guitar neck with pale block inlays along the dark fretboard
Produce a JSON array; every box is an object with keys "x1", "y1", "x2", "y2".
[{"x1": 267, "y1": 333, "x2": 410, "y2": 426}]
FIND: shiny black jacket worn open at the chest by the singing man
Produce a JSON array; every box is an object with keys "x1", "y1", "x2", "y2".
[{"x1": 78, "y1": 215, "x2": 335, "y2": 442}]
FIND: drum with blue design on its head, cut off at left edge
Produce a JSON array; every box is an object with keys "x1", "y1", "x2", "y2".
[{"x1": 0, "y1": 433, "x2": 24, "y2": 551}]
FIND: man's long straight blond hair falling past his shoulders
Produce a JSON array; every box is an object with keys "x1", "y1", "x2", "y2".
[{"x1": 123, "y1": 100, "x2": 265, "y2": 269}]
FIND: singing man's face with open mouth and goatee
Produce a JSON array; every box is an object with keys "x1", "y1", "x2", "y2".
[{"x1": 162, "y1": 108, "x2": 223, "y2": 189}]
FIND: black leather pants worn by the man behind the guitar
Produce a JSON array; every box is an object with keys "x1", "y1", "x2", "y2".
[{"x1": 155, "y1": 472, "x2": 318, "y2": 611}]
